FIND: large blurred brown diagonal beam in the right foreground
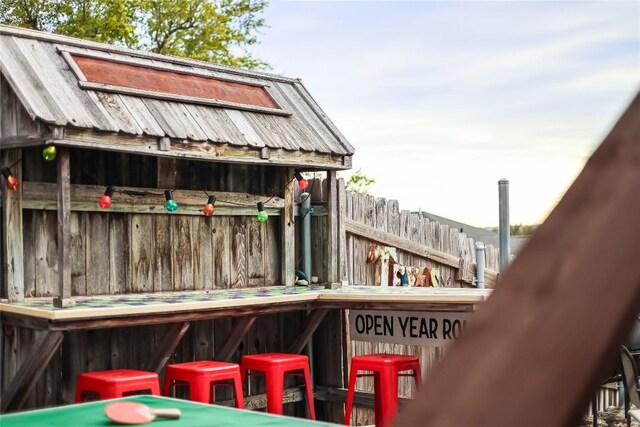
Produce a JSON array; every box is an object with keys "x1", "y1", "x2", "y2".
[{"x1": 395, "y1": 94, "x2": 640, "y2": 427}]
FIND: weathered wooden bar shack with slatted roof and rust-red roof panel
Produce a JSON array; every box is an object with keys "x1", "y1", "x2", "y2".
[{"x1": 0, "y1": 22, "x2": 354, "y2": 410}]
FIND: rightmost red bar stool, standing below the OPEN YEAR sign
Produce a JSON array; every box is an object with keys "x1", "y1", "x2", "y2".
[{"x1": 344, "y1": 353, "x2": 422, "y2": 427}]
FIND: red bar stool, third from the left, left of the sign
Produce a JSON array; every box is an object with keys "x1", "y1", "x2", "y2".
[{"x1": 240, "y1": 353, "x2": 316, "y2": 420}]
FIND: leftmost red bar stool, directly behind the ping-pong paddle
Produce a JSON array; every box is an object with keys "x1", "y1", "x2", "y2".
[{"x1": 76, "y1": 369, "x2": 160, "y2": 403}]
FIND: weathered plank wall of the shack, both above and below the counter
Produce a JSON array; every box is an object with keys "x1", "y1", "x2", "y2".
[{"x1": 0, "y1": 148, "x2": 312, "y2": 415}]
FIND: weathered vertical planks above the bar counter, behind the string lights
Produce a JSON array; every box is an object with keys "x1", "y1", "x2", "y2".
[{"x1": 18, "y1": 150, "x2": 282, "y2": 297}]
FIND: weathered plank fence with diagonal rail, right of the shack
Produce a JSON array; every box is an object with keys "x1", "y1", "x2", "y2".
[{"x1": 346, "y1": 185, "x2": 499, "y2": 425}]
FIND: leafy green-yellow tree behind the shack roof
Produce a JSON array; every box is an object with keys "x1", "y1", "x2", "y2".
[{"x1": 0, "y1": 0, "x2": 268, "y2": 69}]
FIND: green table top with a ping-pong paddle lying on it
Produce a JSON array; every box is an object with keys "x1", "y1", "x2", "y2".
[{"x1": 0, "y1": 395, "x2": 334, "y2": 427}]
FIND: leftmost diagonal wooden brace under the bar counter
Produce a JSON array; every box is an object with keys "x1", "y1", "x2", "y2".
[{"x1": 1, "y1": 331, "x2": 64, "y2": 412}]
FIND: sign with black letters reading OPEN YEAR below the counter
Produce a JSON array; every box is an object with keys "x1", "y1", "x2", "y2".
[{"x1": 349, "y1": 310, "x2": 471, "y2": 347}]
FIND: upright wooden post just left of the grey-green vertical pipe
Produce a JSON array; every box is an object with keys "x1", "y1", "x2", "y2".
[{"x1": 280, "y1": 168, "x2": 296, "y2": 286}]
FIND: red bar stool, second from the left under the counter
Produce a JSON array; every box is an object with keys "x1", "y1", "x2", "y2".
[{"x1": 162, "y1": 360, "x2": 244, "y2": 409}]
